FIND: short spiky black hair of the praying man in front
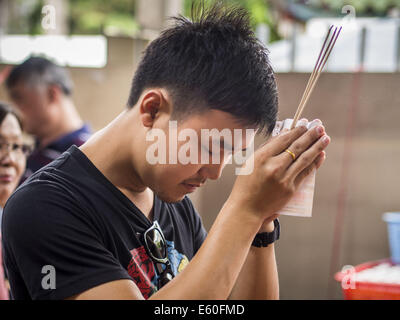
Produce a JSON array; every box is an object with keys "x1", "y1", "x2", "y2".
[{"x1": 128, "y1": 1, "x2": 278, "y2": 133}]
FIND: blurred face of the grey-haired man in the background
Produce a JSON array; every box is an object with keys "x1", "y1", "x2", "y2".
[{"x1": 9, "y1": 81, "x2": 50, "y2": 136}]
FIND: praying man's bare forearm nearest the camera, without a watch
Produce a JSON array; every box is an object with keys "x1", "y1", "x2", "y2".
[{"x1": 151, "y1": 200, "x2": 260, "y2": 299}]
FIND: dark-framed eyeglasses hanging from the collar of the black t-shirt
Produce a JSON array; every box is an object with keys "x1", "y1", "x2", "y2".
[{"x1": 143, "y1": 221, "x2": 174, "y2": 289}]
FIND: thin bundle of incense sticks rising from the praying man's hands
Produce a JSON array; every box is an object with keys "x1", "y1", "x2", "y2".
[{"x1": 291, "y1": 26, "x2": 342, "y2": 129}]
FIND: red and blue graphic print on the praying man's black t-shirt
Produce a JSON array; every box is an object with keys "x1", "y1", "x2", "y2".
[{"x1": 127, "y1": 241, "x2": 189, "y2": 299}]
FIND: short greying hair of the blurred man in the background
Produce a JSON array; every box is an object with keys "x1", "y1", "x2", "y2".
[{"x1": 6, "y1": 56, "x2": 73, "y2": 96}]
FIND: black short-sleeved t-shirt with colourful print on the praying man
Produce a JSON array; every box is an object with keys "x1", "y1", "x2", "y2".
[{"x1": 2, "y1": 146, "x2": 206, "y2": 299}]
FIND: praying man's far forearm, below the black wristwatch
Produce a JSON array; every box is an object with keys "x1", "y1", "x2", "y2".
[{"x1": 229, "y1": 223, "x2": 279, "y2": 300}]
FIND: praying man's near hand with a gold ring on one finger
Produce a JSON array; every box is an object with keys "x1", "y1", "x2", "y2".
[{"x1": 228, "y1": 121, "x2": 330, "y2": 226}]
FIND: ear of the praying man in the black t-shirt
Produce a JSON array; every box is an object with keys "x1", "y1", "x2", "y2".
[{"x1": 139, "y1": 89, "x2": 169, "y2": 127}]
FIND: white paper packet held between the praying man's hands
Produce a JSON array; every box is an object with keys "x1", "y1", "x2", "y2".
[{"x1": 272, "y1": 119, "x2": 321, "y2": 217}]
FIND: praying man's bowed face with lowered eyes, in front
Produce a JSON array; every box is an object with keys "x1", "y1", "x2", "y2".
[{"x1": 139, "y1": 110, "x2": 254, "y2": 202}]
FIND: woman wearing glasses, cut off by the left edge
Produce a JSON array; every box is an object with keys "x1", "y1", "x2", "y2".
[{"x1": 0, "y1": 102, "x2": 30, "y2": 300}]
